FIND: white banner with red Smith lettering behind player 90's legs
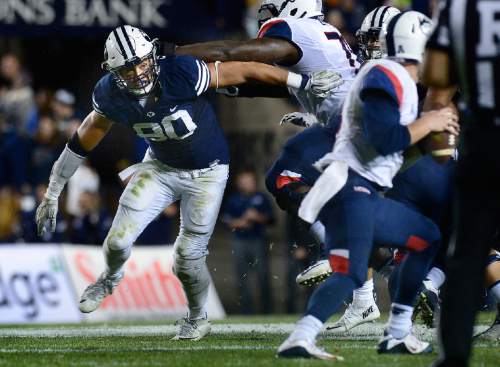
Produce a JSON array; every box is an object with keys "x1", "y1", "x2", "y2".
[{"x1": 62, "y1": 245, "x2": 225, "y2": 321}]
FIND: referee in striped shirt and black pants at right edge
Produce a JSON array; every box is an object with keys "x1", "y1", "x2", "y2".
[{"x1": 423, "y1": 0, "x2": 500, "y2": 367}]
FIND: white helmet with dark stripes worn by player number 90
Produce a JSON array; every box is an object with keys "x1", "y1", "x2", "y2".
[{"x1": 102, "y1": 25, "x2": 160, "y2": 97}]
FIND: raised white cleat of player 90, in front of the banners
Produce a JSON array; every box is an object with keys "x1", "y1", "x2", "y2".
[{"x1": 78, "y1": 272, "x2": 123, "y2": 313}]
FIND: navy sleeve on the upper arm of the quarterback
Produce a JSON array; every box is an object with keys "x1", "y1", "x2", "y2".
[{"x1": 361, "y1": 89, "x2": 411, "y2": 155}]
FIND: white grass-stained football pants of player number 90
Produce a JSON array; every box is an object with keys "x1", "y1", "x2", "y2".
[{"x1": 104, "y1": 153, "x2": 229, "y2": 319}]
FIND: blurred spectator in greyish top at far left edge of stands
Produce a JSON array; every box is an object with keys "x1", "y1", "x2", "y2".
[{"x1": 0, "y1": 54, "x2": 35, "y2": 134}]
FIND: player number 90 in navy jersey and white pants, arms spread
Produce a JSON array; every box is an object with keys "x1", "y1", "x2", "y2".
[{"x1": 36, "y1": 25, "x2": 341, "y2": 340}]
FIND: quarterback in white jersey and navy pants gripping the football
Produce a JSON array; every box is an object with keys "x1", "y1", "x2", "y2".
[{"x1": 278, "y1": 11, "x2": 458, "y2": 360}]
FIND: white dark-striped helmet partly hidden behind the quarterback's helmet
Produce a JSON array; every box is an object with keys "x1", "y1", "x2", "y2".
[{"x1": 356, "y1": 6, "x2": 401, "y2": 60}]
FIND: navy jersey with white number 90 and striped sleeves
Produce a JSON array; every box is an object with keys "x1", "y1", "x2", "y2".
[{"x1": 92, "y1": 56, "x2": 229, "y2": 169}]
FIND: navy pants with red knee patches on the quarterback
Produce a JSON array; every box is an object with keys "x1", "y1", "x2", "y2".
[{"x1": 306, "y1": 171, "x2": 441, "y2": 322}]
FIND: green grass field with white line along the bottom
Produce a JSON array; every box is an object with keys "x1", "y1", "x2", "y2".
[{"x1": 0, "y1": 314, "x2": 500, "y2": 367}]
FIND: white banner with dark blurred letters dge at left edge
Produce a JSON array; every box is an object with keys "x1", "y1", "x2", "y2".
[{"x1": 0, "y1": 244, "x2": 82, "y2": 324}]
